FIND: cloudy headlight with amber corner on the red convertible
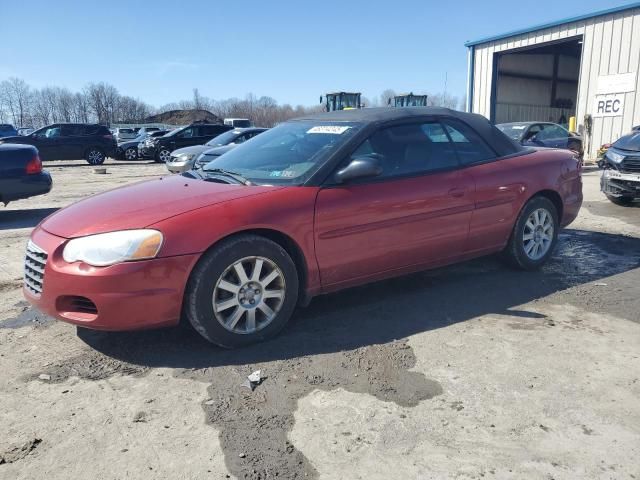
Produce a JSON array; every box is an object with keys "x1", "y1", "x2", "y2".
[{"x1": 62, "y1": 230, "x2": 163, "y2": 267}]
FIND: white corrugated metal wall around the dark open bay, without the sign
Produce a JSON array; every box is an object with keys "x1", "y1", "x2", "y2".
[{"x1": 471, "y1": 8, "x2": 640, "y2": 157}]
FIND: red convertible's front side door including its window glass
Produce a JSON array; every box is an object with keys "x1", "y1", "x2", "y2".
[{"x1": 315, "y1": 121, "x2": 474, "y2": 289}]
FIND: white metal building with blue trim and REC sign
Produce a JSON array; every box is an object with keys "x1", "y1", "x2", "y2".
[{"x1": 465, "y1": 2, "x2": 640, "y2": 157}]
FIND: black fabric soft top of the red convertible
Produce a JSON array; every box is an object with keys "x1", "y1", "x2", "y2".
[{"x1": 296, "y1": 107, "x2": 524, "y2": 157}]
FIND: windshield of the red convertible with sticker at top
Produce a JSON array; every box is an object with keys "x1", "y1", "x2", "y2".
[{"x1": 203, "y1": 121, "x2": 362, "y2": 185}]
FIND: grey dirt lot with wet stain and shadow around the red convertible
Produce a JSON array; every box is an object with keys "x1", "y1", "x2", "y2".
[{"x1": 0, "y1": 162, "x2": 640, "y2": 479}]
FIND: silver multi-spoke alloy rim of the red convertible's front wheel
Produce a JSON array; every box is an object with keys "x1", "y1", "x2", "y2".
[{"x1": 213, "y1": 256, "x2": 286, "y2": 334}]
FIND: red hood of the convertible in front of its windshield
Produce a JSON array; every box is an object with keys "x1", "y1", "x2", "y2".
[{"x1": 40, "y1": 175, "x2": 282, "y2": 238}]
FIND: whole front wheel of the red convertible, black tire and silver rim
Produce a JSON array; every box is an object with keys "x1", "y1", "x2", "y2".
[{"x1": 184, "y1": 235, "x2": 298, "y2": 348}]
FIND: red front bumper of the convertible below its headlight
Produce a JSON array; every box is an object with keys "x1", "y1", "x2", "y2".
[{"x1": 23, "y1": 228, "x2": 198, "y2": 331}]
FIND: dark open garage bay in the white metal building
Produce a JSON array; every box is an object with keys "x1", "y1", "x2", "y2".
[{"x1": 491, "y1": 36, "x2": 582, "y2": 126}]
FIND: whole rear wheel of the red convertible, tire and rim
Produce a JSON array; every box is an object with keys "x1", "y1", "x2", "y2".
[{"x1": 504, "y1": 197, "x2": 559, "y2": 270}]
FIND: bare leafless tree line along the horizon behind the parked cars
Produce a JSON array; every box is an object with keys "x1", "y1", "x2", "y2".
[{"x1": 0, "y1": 77, "x2": 461, "y2": 128}]
